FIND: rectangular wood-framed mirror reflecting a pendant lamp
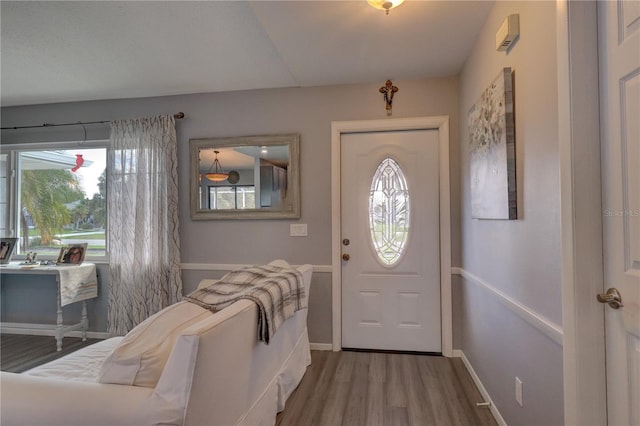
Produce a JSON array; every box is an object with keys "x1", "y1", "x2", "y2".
[{"x1": 189, "y1": 133, "x2": 300, "y2": 220}]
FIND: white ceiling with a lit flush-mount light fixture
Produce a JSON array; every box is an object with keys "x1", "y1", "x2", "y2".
[{"x1": 0, "y1": 0, "x2": 493, "y2": 106}]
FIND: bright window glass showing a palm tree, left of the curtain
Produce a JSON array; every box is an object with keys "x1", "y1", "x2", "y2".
[{"x1": 0, "y1": 142, "x2": 107, "y2": 260}]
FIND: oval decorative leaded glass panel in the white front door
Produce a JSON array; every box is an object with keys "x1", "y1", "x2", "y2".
[{"x1": 369, "y1": 157, "x2": 409, "y2": 266}]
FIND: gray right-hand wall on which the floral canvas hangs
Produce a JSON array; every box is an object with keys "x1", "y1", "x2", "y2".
[{"x1": 454, "y1": 1, "x2": 563, "y2": 425}]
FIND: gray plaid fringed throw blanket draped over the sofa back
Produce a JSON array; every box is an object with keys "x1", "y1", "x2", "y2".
[{"x1": 184, "y1": 265, "x2": 307, "y2": 343}]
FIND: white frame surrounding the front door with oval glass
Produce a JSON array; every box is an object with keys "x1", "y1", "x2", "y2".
[{"x1": 331, "y1": 116, "x2": 453, "y2": 357}]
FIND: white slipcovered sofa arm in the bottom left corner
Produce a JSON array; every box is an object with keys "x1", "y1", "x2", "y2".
[{"x1": 0, "y1": 372, "x2": 158, "y2": 426}]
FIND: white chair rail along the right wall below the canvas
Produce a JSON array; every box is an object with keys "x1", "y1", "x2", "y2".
[{"x1": 451, "y1": 267, "x2": 563, "y2": 346}]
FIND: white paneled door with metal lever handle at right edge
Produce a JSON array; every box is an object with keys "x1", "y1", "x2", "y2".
[{"x1": 598, "y1": 0, "x2": 640, "y2": 425}]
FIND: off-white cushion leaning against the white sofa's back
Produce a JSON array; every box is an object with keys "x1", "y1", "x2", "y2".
[{"x1": 98, "y1": 302, "x2": 213, "y2": 387}]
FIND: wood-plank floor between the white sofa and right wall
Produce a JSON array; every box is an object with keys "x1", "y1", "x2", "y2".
[{"x1": 276, "y1": 351, "x2": 497, "y2": 426}]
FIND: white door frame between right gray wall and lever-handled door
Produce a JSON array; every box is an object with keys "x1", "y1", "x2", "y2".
[{"x1": 556, "y1": 0, "x2": 607, "y2": 425}]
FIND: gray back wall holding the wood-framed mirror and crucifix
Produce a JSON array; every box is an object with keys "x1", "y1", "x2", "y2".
[{"x1": 1, "y1": 77, "x2": 460, "y2": 343}]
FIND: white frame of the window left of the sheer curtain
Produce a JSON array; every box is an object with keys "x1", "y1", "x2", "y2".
[{"x1": 0, "y1": 139, "x2": 111, "y2": 263}]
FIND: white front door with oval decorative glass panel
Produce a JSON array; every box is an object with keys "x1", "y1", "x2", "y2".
[{"x1": 341, "y1": 130, "x2": 442, "y2": 352}]
